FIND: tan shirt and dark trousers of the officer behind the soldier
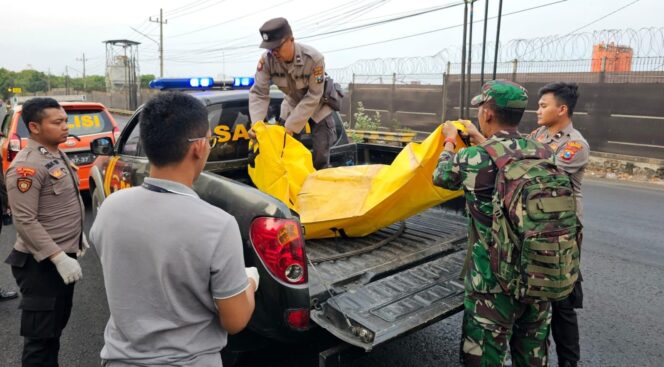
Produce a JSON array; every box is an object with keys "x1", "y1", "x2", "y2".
[{"x1": 529, "y1": 122, "x2": 590, "y2": 366}]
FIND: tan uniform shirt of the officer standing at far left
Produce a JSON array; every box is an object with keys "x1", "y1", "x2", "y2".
[{"x1": 6, "y1": 139, "x2": 85, "y2": 261}]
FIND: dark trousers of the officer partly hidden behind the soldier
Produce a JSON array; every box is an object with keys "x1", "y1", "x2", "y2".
[{"x1": 551, "y1": 281, "x2": 583, "y2": 366}]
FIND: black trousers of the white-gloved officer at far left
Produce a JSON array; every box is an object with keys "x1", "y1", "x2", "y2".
[{"x1": 5, "y1": 250, "x2": 75, "y2": 367}]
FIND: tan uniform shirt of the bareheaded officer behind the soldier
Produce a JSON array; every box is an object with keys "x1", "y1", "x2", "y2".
[{"x1": 530, "y1": 122, "x2": 590, "y2": 219}]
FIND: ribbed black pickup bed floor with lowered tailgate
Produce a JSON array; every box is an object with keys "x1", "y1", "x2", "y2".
[{"x1": 306, "y1": 209, "x2": 467, "y2": 351}]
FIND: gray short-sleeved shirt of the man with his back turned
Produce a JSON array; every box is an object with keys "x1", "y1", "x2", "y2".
[{"x1": 90, "y1": 178, "x2": 249, "y2": 366}]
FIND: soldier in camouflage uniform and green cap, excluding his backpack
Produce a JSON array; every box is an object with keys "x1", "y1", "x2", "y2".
[{"x1": 433, "y1": 81, "x2": 552, "y2": 366}]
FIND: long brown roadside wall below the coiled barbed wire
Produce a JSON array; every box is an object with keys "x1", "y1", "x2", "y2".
[{"x1": 342, "y1": 73, "x2": 664, "y2": 159}]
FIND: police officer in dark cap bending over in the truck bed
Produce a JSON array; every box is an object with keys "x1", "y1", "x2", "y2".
[{"x1": 249, "y1": 18, "x2": 336, "y2": 169}]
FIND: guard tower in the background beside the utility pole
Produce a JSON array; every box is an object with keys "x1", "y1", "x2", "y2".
[{"x1": 104, "y1": 39, "x2": 140, "y2": 111}]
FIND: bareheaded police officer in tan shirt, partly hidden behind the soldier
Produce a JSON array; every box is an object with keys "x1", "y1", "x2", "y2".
[{"x1": 530, "y1": 83, "x2": 590, "y2": 367}]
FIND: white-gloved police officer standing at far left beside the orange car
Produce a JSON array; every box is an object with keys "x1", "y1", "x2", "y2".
[{"x1": 5, "y1": 98, "x2": 87, "y2": 366}]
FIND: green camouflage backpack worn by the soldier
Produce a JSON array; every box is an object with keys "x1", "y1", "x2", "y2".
[{"x1": 482, "y1": 140, "x2": 581, "y2": 302}]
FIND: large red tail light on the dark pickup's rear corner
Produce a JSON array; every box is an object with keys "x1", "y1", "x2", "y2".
[{"x1": 251, "y1": 217, "x2": 307, "y2": 284}]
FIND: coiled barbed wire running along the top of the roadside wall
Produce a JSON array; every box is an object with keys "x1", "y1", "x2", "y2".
[{"x1": 327, "y1": 27, "x2": 664, "y2": 83}]
